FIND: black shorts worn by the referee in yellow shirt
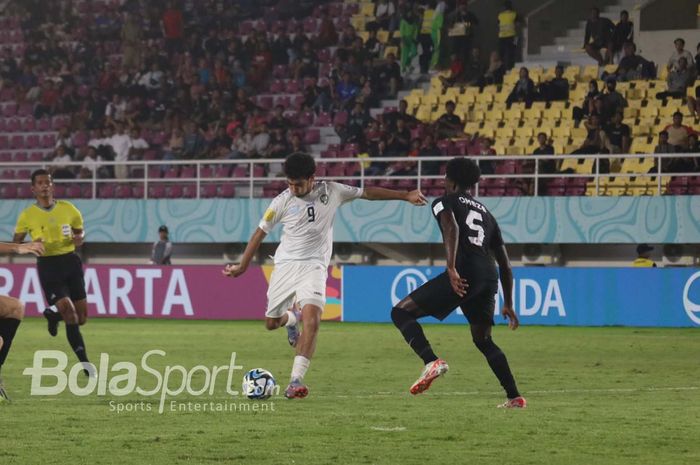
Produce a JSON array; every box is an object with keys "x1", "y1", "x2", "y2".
[{"x1": 36, "y1": 253, "x2": 86, "y2": 305}]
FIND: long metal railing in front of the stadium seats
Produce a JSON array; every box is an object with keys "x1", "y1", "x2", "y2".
[{"x1": 0, "y1": 153, "x2": 700, "y2": 199}]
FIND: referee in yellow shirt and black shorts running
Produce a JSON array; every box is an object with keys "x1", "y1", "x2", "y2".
[{"x1": 13, "y1": 169, "x2": 93, "y2": 375}]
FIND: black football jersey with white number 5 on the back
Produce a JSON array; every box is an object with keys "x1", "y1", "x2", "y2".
[{"x1": 432, "y1": 193, "x2": 503, "y2": 281}]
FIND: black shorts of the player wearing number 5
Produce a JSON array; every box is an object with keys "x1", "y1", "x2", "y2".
[{"x1": 410, "y1": 271, "x2": 498, "y2": 326}]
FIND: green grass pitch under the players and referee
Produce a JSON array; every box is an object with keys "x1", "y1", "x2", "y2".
[{"x1": 0, "y1": 319, "x2": 700, "y2": 465}]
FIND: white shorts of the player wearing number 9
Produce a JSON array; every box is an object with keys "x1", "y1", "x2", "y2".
[{"x1": 265, "y1": 262, "x2": 328, "y2": 318}]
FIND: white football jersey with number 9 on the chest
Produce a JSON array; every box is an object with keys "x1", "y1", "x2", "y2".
[{"x1": 259, "y1": 182, "x2": 362, "y2": 267}]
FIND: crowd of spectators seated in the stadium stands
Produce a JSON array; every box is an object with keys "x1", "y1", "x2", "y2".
[{"x1": 0, "y1": 0, "x2": 700, "y2": 198}]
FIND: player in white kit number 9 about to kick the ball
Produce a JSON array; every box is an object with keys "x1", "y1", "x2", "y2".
[{"x1": 223, "y1": 153, "x2": 426, "y2": 399}]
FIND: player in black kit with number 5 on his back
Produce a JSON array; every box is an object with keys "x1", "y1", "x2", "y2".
[{"x1": 391, "y1": 158, "x2": 527, "y2": 408}]
